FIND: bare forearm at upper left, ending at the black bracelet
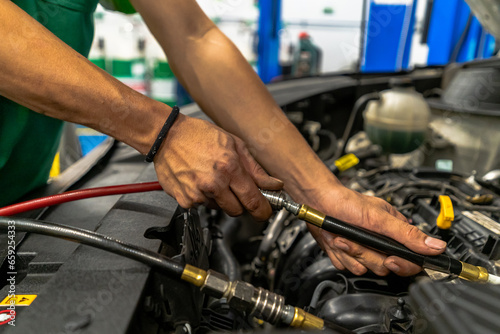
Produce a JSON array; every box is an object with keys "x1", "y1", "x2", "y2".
[{"x1": 0, "y1": 0, "x2": 169, "y2": 153}]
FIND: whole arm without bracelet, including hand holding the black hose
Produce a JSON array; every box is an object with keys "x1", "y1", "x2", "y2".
[{"x1": 132, "y1": 0, "x2": 444, "y2": 275}]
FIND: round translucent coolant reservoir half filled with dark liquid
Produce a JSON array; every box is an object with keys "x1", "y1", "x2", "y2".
[{"x1": 364, "y1": 78, "x2": 430, "y2": 154}]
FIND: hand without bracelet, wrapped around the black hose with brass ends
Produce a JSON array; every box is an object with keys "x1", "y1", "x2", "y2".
[{"x1": 300, "y1": 184, "x2": 446, "y2": 276}]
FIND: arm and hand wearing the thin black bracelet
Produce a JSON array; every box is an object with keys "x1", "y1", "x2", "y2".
[{"x1": 0, "y1": 0, "x2": 281, "y2": 219}]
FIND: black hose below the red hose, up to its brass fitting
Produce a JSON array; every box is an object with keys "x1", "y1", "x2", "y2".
[{"x1": 0, "y1": 217, "x2": 184, "y2": 278}]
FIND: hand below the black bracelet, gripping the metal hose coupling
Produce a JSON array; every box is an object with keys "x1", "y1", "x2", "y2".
[{"x1": 154, "y1": 114, "x2": 283, "y2": 220}]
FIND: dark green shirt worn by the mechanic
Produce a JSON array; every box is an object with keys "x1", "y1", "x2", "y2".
[{"x1": 0, "y1": 0, "x2": 123, "y2": 206}]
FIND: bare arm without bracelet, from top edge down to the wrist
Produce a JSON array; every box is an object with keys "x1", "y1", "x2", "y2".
[{"x1": 134, "y1": 0, "x2": 336, "y2": 201}]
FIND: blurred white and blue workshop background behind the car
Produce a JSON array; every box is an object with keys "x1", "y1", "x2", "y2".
[{"x1": 68, "y1": 0, "x2": 496, "y2": 162}]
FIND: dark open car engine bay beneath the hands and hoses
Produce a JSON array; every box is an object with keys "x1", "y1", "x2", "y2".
[{"x1": 0, "y1": 60, "x2": 500, "y2": 334}]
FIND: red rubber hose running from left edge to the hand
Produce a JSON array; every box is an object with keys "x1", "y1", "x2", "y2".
[{"x1": 0, "y1": 182, "x2": 162, "y2": 216}]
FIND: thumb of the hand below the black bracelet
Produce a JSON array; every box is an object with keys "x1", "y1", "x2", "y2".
[{"x1": 232, "y1": 140, "x2": 283, "y2": 190}]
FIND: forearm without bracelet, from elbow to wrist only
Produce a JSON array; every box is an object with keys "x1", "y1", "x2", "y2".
[{"x1": 176, "y1": 30, "x2": 330, "y2": 197}]
